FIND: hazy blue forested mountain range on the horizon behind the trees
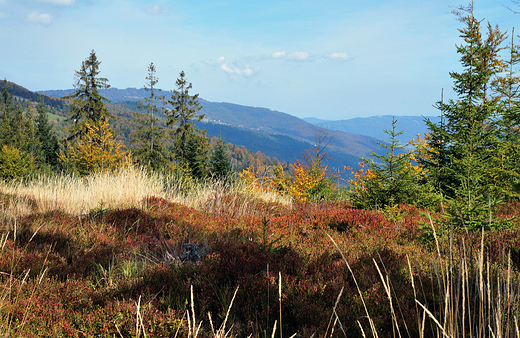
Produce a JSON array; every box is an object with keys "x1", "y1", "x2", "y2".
[{"x1": 6, "y1": 84, "x2": 434, "y2": 168}]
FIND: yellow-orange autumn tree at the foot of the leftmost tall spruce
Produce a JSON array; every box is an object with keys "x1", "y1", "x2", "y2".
[{"x1": 60, "y1": 118, "x2": 131, "y2": 176}]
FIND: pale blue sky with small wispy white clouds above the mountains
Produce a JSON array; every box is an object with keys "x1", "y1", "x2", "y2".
[{"x1": 0, "y1": 0, "x2": 520, "y2": 120}]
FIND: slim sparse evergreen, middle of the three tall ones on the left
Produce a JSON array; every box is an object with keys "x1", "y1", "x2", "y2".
[{"x1": 132, "y1": 62, "x2": 167, "y2": 170}]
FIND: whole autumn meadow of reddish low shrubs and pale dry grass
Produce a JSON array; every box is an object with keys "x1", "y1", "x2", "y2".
[{"x1": 0, "y1": 168, "x2": 520, "y2": 337}]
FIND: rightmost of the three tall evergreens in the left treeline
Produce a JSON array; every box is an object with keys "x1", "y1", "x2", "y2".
[{"x1": 166, "y1": 72, "x2": 208, "y2": 173}]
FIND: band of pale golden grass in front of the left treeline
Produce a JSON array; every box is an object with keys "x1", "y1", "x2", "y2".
[{"x1": 0, "y1": 166, "x2": 292, "y2": 217}]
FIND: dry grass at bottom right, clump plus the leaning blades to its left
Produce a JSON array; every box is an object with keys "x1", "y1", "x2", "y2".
[{"x1": 329, "y1": 218, "x2": 520, "y2": 338}]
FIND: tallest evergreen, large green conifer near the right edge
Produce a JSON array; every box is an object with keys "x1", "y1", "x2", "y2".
[{"x1": 425, "y1": 3, "x2": 519, "y2": 229}]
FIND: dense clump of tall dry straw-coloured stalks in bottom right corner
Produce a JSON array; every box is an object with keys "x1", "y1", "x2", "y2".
[{"x1": 409, "y1": 225, "x2": 520, "y2": 338}]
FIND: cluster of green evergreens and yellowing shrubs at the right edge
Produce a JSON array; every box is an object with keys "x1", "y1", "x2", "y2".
[{"x1": 351, "y1": 4, "x2": 520, "y2": 229}]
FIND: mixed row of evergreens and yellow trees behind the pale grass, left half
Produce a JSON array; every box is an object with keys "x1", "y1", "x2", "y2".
[{"x1": 0, "y1": 51, "x2": 278, "y2": 184}]
